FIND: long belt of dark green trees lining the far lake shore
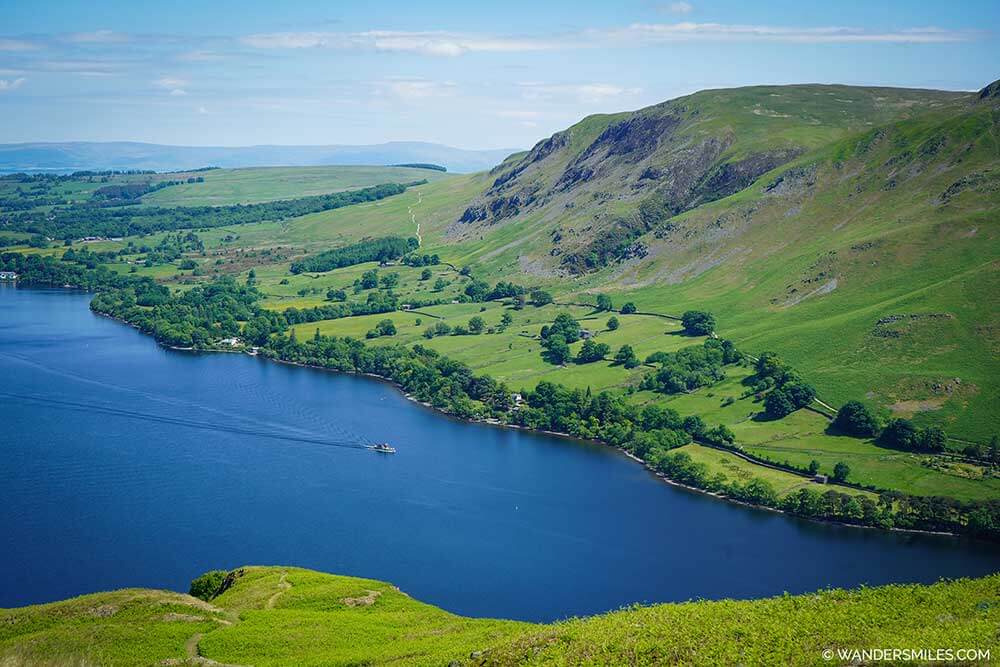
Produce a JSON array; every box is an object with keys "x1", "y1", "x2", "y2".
[{"x1": 0, "y1": 254, "x2": 1000, "y2": 537}]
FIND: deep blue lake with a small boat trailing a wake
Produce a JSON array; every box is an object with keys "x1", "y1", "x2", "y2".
[{"x1": 0, "y1": 285, "x2": 1000, "y2": 620}]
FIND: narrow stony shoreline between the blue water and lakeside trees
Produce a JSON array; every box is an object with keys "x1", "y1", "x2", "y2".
[{"x1": 91, "y1": 310, "x2": 975, "y2": 539}]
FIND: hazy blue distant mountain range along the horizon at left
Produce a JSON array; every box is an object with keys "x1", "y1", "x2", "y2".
[{"x1": 0, "y1": 141, "x2": 514, "y2": 172}]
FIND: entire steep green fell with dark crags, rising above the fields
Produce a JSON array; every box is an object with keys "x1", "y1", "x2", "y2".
[{"x1": 440, "y1": 84, "x2": 1000, "y2": 442}]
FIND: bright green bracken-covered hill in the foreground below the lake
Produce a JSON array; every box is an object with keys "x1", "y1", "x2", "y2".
[{"x1": 0, "y1": 567, "x2": 1000, "y2": 667}]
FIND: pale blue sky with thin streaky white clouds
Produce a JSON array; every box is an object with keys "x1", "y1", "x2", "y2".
[{"x1": 0, "y1": 0, "x2": 1000, "y2": 148}]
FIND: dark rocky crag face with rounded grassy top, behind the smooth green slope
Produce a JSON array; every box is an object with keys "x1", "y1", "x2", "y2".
[{"x1": 449, "y1": 85, "x2": 970, "y2": 273}]
